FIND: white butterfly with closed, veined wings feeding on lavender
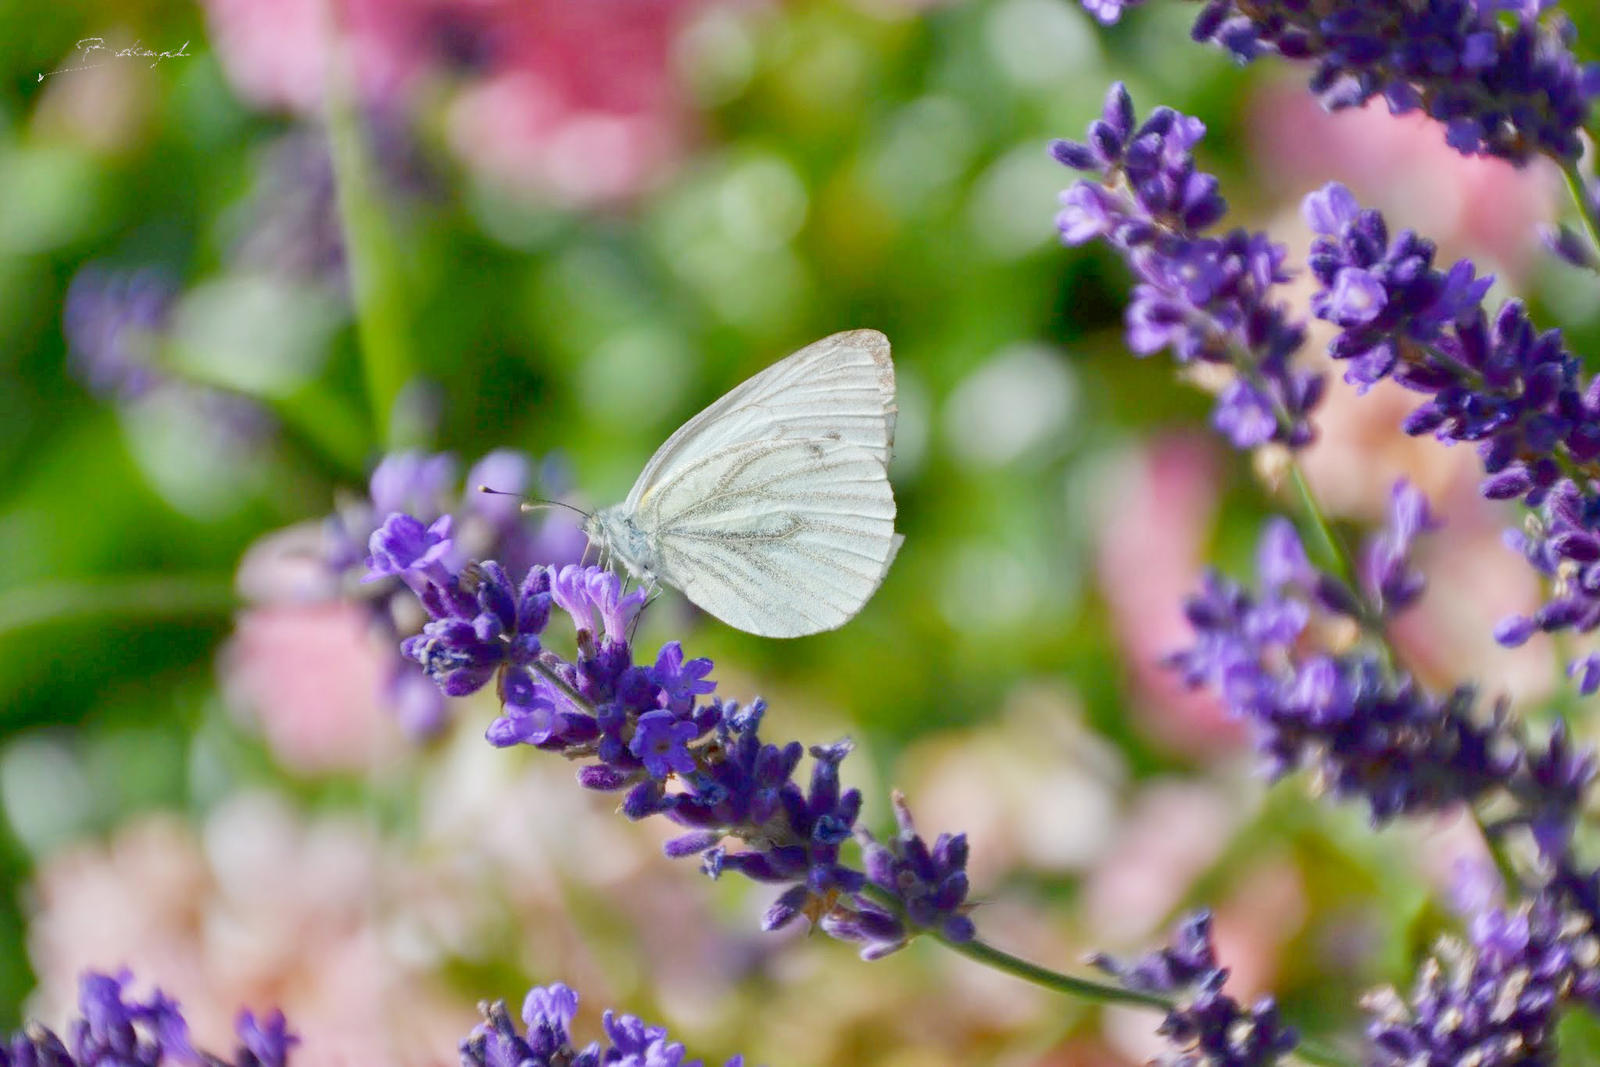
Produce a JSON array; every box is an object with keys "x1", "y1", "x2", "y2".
[{"x1": 584, "y1": 330, "x2": 901, "y2": 637}]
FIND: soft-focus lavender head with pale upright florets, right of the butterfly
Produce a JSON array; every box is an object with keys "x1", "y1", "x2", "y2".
[{"x1": 1168, "y1": 486, "x2": 1522, "y2": 822}]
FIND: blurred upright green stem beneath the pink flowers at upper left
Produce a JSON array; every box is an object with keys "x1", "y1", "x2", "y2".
[{"x1": 323, "y1": 3, "x2": 413, "y2": 446}]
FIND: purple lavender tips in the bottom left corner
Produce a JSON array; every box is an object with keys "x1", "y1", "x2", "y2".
[{"x1": 0, "y1": 971, "x2": 299, "y2": 1067}]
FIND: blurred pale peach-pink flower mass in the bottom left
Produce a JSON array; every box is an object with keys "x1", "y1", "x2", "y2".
[{"x1": 29, "y1": 797, "x2": 472, "y2": 1067}]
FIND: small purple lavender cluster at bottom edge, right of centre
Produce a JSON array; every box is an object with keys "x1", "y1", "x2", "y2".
[{"x1": 1091, "y1": 910, "x2": 1299, "y2": 1067}]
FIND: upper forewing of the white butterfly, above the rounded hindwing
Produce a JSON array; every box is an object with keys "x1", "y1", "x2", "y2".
[{"x1": 626, "y1": 330, "x2": 894, "y2": 512}]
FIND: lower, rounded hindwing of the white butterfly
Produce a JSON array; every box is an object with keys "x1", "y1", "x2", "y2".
[{"x1": 638, "y1": 437, "x2": 901, "y2": 637}]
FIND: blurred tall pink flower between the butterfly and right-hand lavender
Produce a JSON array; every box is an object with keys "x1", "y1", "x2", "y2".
[{"x1": 1096, "y1": 435, "x2": 1243, "y2": 755}]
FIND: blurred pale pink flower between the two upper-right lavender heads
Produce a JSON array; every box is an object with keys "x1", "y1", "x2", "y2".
[{"x1": 1251, "y1": 80, "x2": 1560, "y2": 275}]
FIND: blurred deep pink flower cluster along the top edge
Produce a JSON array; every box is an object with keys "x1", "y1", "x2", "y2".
[{"x1": 205, "y1": 0, "x2": 698, "y2": 206}]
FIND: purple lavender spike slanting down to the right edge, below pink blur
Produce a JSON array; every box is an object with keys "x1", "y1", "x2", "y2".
[{"x1": 1306, "y1": 184, "x2": 1600, "y2": 693}]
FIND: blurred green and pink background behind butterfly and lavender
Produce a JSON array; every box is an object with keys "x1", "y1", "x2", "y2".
[{"x1": 0, "y1": 0, "x2": 1600, "y2": 1067}]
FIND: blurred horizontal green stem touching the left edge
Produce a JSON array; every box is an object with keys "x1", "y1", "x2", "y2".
[{"x1": 0, "y1": 574, "x2": 238, "y2": 635}]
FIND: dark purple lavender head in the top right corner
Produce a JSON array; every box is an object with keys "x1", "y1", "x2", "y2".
[{"x1": 1190, "y1": 0, "x2": 1600, "y2": 165}]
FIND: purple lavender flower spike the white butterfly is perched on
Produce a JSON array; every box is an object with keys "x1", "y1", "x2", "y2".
[{"x1": 384, "y1": 514, "x2": 974, "y2": 958}]
